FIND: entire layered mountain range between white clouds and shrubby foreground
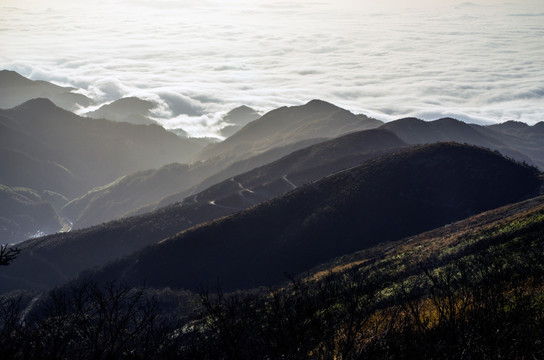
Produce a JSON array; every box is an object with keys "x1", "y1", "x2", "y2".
[{"x1": 0, "y1": 71, "x2": 544, "y2": 339}]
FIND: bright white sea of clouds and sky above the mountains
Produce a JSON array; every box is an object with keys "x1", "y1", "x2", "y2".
[{"x1": 0, "y1": 0, "x2": 544, "y2": 136}]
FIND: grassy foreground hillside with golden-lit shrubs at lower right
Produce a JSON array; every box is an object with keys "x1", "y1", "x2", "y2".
[{"x1": 182, "y1": 197, "x2": 544, "y2": 359}]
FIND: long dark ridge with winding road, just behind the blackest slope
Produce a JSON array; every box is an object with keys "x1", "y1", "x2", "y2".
[{"x1": 0, "y1": 130, "x2": 404, "y2": 291}]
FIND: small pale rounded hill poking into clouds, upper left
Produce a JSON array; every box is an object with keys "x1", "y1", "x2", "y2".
[{"x1": 85, "y1": 97, "x2": 156, "y2": 125}]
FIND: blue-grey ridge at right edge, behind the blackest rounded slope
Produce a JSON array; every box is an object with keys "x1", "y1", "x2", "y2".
[{"x1": 382, "y1": 118, "x2": 544, "y2": 169}]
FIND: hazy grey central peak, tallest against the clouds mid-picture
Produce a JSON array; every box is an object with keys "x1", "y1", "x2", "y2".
[{"x1": 199, "y1": 100, "x2": 382, "y2": 159}]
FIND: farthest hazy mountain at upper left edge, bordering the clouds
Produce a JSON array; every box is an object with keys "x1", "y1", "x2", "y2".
[{"x1": 0, "y1": 70, "x2": 93, "y2": 111}]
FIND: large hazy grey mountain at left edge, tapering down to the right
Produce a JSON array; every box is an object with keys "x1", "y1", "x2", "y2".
[{"x1": 0, "y1": 99, "x2": 204, "y2": 198}]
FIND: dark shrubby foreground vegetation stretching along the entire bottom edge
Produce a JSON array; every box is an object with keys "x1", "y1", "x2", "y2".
[{"x1": 0, "y1": 197, "x2": 544, "y2": 359}]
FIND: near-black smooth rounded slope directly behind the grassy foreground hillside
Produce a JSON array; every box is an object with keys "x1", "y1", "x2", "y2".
[{"x1": 89, "y1": 144, "x2": 541, "y2": 289}]
